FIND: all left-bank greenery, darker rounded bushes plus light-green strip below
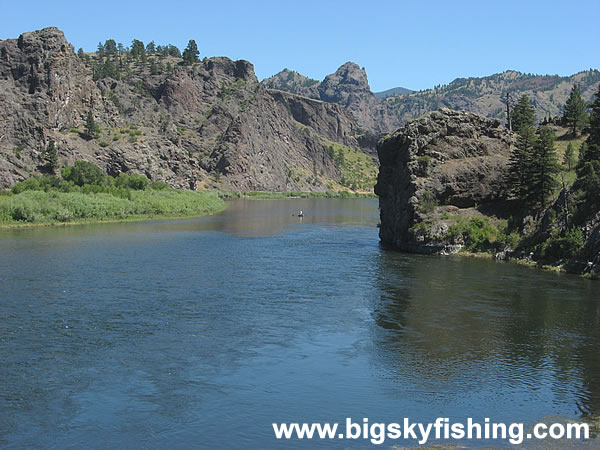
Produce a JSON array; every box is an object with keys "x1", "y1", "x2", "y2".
[{"x1": 0, "y1": 161, "x2": 224, "y2": 226}]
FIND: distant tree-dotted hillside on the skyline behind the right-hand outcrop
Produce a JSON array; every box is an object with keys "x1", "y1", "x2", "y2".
[{"x1": 385, "y1": 70, "x2": 600, "y2": 122}]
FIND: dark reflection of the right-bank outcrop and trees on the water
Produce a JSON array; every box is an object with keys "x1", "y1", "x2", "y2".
[{"x1": 373, "y1": 252, "x2": 600, "y2": 417}]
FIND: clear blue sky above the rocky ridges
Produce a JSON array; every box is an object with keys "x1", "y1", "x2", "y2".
[{"x1": 0, "y1": 0, "x2": 600, "y2": 91}]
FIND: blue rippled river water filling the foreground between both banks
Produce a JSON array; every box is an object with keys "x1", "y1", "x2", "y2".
[{"x1": 0, "y1": 200, "x2": 600, "y2": 448}]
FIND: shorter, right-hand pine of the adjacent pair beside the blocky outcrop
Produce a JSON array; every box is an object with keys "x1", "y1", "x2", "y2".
[{"x1": 527, "y1": 127, "x2": 560, "y2": 209}]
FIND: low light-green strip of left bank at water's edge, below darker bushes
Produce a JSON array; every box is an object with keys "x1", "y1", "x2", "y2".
[{"x1": 0, "y1": 189, "x2": 226, "y2": 229}]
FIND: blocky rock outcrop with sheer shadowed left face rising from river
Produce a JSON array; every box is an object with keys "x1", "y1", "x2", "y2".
[{"x1": 375, "y1": 109, "x2": 513, "y2": 253}]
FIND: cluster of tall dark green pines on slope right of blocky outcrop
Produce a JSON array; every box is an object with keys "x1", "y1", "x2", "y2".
[{"x1": 507, "y1": 85, "x2": 600, "y2": 233}]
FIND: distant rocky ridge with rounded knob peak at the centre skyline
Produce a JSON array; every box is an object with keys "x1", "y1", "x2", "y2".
[{"x1": 262, "y1": 62, "x2": 402, "y2": 136}]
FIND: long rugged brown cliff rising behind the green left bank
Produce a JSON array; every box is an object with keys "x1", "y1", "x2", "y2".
[{"x1": 0, "y1": 28, "x2": 368, "y2": 191}]
